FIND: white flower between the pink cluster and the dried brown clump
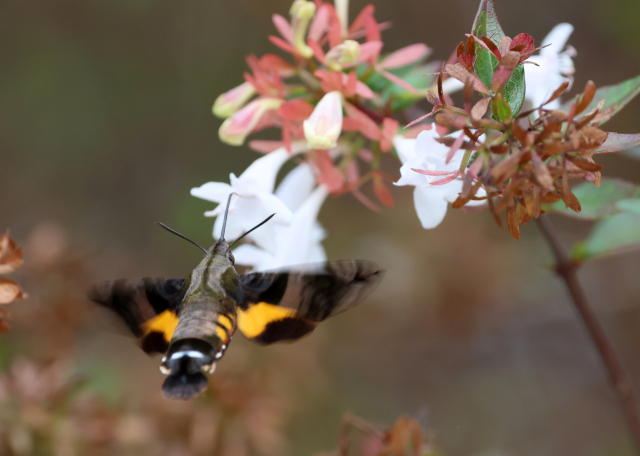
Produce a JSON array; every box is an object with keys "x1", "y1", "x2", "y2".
[{"x1": 393, "y1": 128, "x2": 485, "y2": 229}]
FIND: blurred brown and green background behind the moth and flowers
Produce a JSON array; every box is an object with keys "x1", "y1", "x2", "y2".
[{"x1": 0, "y1": 0, "x2": 640, "y2": 456}]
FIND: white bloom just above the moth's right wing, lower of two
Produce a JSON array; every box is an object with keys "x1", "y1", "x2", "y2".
[{"x1": 233, "y1": 165, "x2": 329, "y2": 270}]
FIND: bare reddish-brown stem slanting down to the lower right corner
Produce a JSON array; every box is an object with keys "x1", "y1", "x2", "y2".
[{"x1": 536, "y1": 215, "x2": 640, "y2": 453}]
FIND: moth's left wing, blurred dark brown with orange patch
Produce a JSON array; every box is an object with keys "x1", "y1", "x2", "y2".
[{"x1": 87, "y1": 277, "x2": 186, "y2": 353}]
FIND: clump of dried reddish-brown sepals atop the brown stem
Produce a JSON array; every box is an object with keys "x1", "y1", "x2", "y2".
[{"x1": 427, "y1": 71, "x2": 615, "y2": 239}]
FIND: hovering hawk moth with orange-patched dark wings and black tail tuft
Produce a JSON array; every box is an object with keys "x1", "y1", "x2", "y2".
[{"x1": 88, "y1": 195, "x2": 384, "y2": 400}]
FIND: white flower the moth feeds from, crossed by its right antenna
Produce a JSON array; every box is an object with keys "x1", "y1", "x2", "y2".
[{"x1": 191, "y1": 147, "x2": 292, "y2": 246}]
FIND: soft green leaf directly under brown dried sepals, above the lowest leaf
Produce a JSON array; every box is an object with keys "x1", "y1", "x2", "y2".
[{"x1": 545, "y1": 179, "x2": 640, "y2": 220}]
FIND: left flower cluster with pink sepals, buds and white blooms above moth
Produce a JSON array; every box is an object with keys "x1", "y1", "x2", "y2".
[{"x1": 196, "y1": 0, "x2": 440, "y2": 269}]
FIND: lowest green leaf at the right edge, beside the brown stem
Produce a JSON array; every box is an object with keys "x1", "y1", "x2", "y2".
[{"x1": 572, "y1": 212, "x2": 640, "y2": 260}]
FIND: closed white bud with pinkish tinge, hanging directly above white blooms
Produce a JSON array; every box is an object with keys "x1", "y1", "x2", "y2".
[{"x1": 303, "y1": 91, "x2": 342, "y2": 149}]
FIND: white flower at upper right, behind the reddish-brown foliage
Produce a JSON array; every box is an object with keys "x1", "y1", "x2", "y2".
[{"x1": 524, "y1": 23, "x2": 576, "y2": 109}]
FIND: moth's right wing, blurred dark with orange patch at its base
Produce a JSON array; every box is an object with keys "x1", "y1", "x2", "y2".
[{"x1": 238, "y1": 260, "x2": 384, "y2": 344}]
